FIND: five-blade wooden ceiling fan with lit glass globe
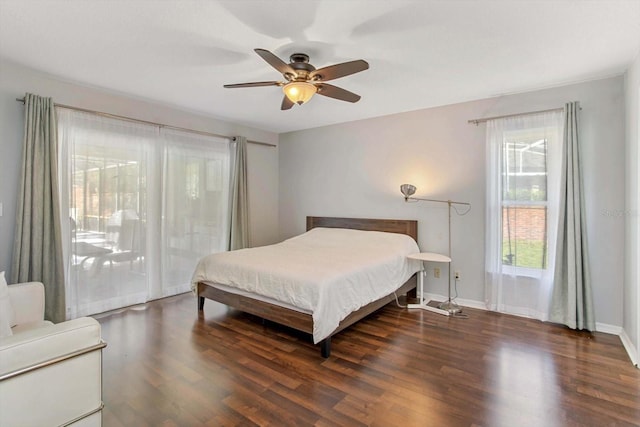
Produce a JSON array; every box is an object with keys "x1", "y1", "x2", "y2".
[{"x1": 224, "y1": 49, "x2": 369, "y2": 110}]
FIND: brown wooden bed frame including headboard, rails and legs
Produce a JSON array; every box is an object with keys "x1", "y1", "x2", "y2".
[{"x1": 198, "y1": 216, "x2": 418, "y2": 358}]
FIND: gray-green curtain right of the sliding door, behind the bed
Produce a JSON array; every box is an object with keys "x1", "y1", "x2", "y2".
[{"x1": 229, "y1": 136, "x2": 249, "y2": 251}]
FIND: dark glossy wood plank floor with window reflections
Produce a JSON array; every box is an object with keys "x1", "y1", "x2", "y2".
[{"x1": 98, "y1": 294, "x2": 640, "y2": 427}]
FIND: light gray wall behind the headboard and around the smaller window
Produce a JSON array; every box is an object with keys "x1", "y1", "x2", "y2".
[{"x1": 279, "y1": 76, "x2": 625, "y2": 329}]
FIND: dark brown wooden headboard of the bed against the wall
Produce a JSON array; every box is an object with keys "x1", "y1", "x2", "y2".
[{"x1": 307, "y1": 216, "x2": 418, "y2": 242}]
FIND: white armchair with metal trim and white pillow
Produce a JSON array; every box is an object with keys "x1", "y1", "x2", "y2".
[{"x1": 0, "y1": 282, "x2": 106, "y2": 427}]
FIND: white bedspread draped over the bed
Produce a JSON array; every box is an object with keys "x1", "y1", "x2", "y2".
[{"x1": 192, "y1": 228, "x2": 420, "y2": 343}]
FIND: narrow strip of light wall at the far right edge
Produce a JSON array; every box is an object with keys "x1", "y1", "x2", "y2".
[{"x1": 623, "y1": 50, "x2": 640, "y2": 364}]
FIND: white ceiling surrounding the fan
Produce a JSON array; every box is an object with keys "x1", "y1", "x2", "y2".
[{"x1": 0, "y1": 0, "x2": 640, "y2": 132}]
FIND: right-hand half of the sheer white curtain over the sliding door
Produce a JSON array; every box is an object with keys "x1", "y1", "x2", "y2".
[{"x1": 158, "y1": 129, "x2": 232, "y2": 298}]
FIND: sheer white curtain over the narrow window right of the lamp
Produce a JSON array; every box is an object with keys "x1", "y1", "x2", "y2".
[{"x1": 485, "y1": 111, "x2": 563, "y2": 320}]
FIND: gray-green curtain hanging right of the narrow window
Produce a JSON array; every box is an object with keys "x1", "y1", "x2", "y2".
[{"x1": 549, "y1": 102, "x2": 595, "y2": 331}]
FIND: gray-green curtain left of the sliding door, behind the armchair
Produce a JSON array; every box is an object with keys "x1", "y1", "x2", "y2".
[{"x1": 11, "y1": 94, "x2": 66, "y2": 322}]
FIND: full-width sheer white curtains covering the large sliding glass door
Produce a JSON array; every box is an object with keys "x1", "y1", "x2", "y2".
[{"x1": 58, "y1": 108, "x2": 230, "y2": 318}]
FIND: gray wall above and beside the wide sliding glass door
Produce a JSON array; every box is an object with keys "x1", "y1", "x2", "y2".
[{"x1": 0, "y1": 61, "x2": 278, "y2": 280}]
